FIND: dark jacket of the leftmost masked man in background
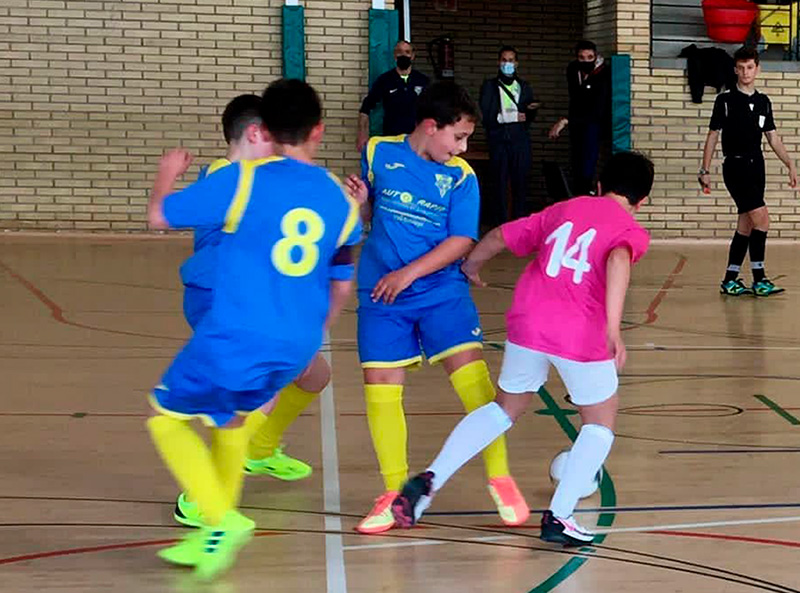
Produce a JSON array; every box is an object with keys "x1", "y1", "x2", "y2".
[{"x1": 361, "y1": 68, "x2": 428, "y2": 136}]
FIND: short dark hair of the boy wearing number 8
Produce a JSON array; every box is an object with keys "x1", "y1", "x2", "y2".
[{"x1": 261, "y1": 78, "x2": 322, "y2": 146}]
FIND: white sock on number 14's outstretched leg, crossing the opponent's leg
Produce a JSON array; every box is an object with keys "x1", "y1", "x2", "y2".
[{"x1": 428, "y1": 402, "x2": 514, "y2": 492}]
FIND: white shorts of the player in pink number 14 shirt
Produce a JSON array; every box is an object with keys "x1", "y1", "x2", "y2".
[{"x1": 497, "y1": 341, "x2": 619, "y2": 406}]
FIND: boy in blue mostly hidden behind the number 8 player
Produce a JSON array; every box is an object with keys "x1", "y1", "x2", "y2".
[{"x1": 173, "y1": 94, "x2": 331, "y2": 527}]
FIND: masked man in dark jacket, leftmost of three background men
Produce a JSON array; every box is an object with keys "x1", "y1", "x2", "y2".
[{"x1": 356, "y1": 41, "x2": 430, "y2": 152}]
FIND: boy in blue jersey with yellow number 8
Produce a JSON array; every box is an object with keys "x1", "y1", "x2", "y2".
[{"x1": 147, "y1": 80, "x2": 361, "y2": 578}]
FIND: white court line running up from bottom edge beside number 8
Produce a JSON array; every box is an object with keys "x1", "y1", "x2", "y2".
[{"x1": 319, "y1": 342, "x2": 347, "y2": 593}]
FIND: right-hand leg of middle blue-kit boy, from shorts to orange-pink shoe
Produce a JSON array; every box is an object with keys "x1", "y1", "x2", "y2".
[{"x1": 419, "y1": 295, "x2": 530, "y2": 525}]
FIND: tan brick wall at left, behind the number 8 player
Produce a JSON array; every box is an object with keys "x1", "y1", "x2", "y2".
[{"x1": 0, "y1": 0, "x2": 384, "y2": 231}]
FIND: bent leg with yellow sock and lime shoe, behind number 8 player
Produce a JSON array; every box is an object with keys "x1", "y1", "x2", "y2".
[{"x1": 245, "y1": 353, "x2": 331, "y2": 481}]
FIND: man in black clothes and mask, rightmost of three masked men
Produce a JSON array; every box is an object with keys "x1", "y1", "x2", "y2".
[{"x1": 549, "y1": 40, "x2": 611, "y2": 196}]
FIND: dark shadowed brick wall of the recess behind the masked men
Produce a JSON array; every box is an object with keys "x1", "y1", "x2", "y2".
[{"x1": 410, "y1": 0, "x2": 583, "y2": 208}]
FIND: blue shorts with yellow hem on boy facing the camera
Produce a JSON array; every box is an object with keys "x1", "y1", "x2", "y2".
[{"x1": 358, "y1": 296, "x2": 483, "y2": 368}]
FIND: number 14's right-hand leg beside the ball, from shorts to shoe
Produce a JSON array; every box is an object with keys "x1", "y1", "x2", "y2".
[{"x1": 541, "y1": 357, "x2": 619, "y2": 546}]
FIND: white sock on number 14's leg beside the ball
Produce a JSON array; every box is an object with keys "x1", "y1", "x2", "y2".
[{"x1": 550, "y1": 424, "x2": 614, "y2": 519}]
